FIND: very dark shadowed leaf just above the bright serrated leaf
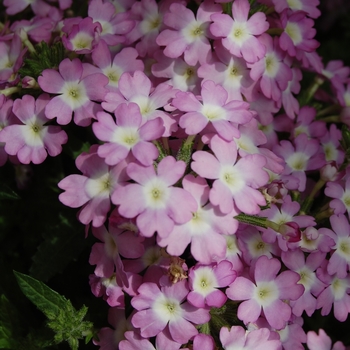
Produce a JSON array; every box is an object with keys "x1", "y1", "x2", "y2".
[{"x1": 29, "y1": 215, "x2": 86, "y2": 282}]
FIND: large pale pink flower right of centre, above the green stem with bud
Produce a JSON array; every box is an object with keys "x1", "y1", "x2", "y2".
[{"x1": 191, "y1": 135, "x2": 269, "y2": 214}]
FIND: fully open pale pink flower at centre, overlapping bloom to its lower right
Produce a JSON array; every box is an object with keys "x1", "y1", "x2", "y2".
[{"x1": 112, "y1": 156, "x2": 197, "y2": 237}]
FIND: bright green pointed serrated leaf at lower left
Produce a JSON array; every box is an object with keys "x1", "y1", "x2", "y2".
[{"x1": 14, "y1": 271, "x2": 68, "y2": 320}]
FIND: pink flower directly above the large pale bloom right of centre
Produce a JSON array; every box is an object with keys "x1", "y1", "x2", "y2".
[{"x1": 172, "y1": 80, "x2": 253, "y2": 141}]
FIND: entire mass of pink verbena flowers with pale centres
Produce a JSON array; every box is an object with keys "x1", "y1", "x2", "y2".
[{"x1": 0, "y1": 0, "x2": 350, "y2": 350}]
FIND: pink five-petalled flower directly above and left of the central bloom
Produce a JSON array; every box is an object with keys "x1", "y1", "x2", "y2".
[{"x1": 92, "y1": 103, "x2": 164, "y2": 166}]
